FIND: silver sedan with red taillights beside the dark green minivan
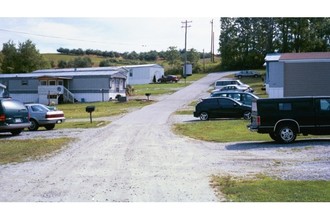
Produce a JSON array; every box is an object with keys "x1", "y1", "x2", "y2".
[{"x1": 25, "y1": 103, "x2": 65, "y2": 131}]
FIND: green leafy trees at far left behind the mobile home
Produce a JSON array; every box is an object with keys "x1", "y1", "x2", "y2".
[{"x1": 0, "y1": 40, "x2": 50, "y2": 73}]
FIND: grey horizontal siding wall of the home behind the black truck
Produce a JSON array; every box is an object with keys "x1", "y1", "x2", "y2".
[{"x1": 284, "y1": 62, "x2": 330, "y2": 97}]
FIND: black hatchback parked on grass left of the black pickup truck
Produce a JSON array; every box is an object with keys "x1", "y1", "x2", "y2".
[{"x1": 194, "y1": 97, "x2": 251, "y2": 121}]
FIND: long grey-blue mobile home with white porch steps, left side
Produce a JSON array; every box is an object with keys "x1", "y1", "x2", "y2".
[{"x1": 0, "y1": 67, "x2": 128, "y2": 104}]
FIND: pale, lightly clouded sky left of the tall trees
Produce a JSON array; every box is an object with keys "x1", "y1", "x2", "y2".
[{"x1": 0, "y1": 17, "x2": 220, "y2": 53}]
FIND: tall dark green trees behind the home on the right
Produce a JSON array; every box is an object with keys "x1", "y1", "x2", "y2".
[{"x1": 219, "y1": 17, "x2": 330, "y2": 70}]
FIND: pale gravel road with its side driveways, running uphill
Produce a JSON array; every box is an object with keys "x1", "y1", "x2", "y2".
[{"x1": 0, "y1": 73, "x2": 330, "y2": 202}]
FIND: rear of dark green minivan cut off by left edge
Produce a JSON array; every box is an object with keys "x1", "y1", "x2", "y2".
[{"x1": 0, "y1": 98, "x2": 30, "y2": 135}]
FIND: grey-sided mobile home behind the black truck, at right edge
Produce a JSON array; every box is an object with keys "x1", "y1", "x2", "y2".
[{"x1": 265, "y1": 52, "x2": 330, "y2": 98}]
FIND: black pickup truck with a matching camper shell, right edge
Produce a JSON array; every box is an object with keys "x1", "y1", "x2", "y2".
[{"x1": 248, "y1": 96, "x2": 330, "y2": 143}]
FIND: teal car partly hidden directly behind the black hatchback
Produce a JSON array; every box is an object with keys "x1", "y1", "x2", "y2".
[{"x1": 211, "y1": 91, "x2": 259, "y2": 106}]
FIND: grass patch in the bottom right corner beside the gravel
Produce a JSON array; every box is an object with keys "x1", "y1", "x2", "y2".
[{"x1": 212, "y1": 176, "x2": 330, "y2": 202}]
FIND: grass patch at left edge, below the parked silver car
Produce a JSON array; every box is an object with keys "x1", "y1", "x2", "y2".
[{"x1": 0, "y1": 138, "x2": 74, "y2": 164}]
